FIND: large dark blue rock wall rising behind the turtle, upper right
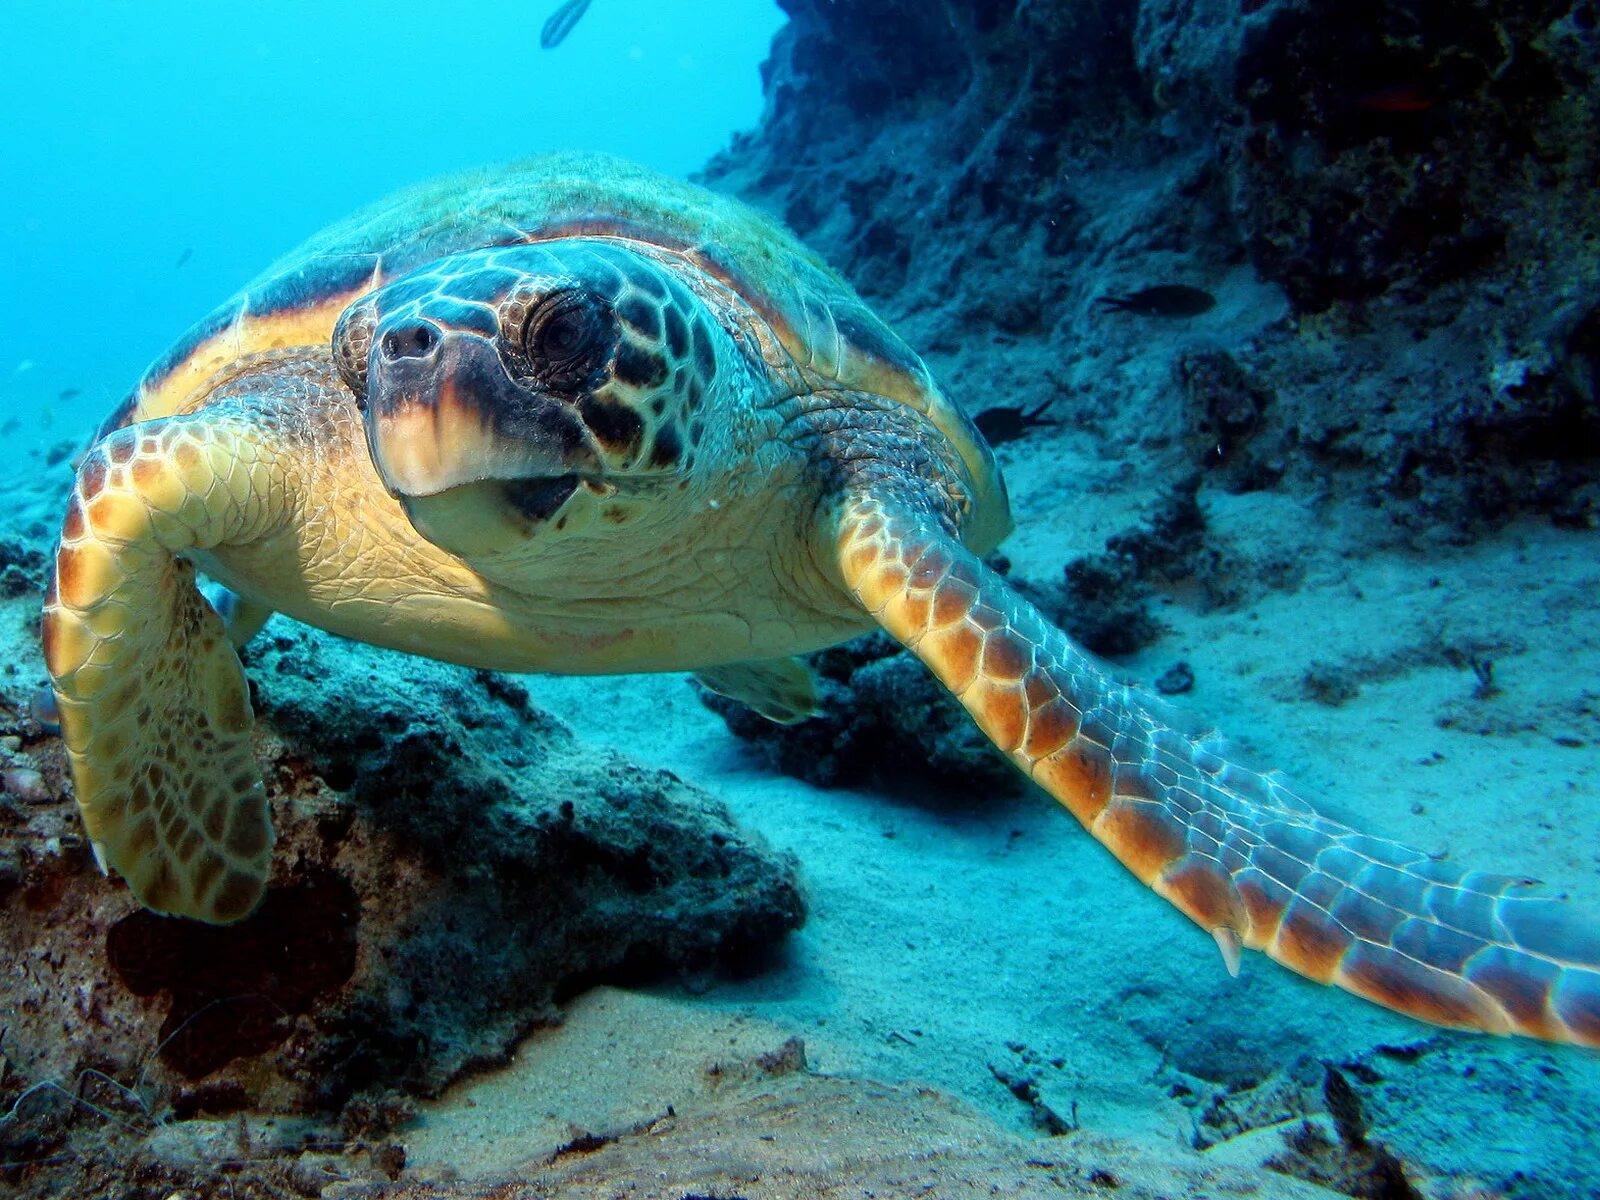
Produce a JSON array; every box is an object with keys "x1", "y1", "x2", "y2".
[{"x1": 706, "y1": 0, "x2": 1600, "y2": 536}]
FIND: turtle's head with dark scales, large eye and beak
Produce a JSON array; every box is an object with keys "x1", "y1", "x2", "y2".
[{"x1": 333, "y1": 240, "x2": 717, "y2": 558}]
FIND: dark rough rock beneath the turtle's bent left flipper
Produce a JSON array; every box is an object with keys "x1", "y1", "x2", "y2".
[{"x1": 0, "y1": 598, "x2": 803, "y2": 1162}]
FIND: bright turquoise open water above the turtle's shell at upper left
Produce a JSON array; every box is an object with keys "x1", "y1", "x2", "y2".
[{"x1": 0, "y1": 0, "x2": 782, "y2": 435}]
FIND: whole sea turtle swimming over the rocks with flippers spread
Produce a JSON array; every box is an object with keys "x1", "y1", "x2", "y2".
[{"x1": 43, "y1": 155, "x2": 1600, "y2": 1045}]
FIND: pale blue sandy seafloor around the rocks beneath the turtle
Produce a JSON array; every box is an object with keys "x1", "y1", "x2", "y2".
[{"x1": 0, "y1": 345, "x2": 1600, "y2": 1197}]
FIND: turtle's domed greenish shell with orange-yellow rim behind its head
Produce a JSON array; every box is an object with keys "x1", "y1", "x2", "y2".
[{"x1": 101, "y1": 154, "x2": 1010, "y2": 552}]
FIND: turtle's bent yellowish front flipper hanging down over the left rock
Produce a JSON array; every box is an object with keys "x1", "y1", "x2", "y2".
[{"x1": 42, "y1": 403, "x2": 286, "y2": 922}]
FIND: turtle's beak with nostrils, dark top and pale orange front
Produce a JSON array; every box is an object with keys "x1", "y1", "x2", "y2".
[{"x1": 365, "y1": 317, "x2": 600, "y2": 557}]
